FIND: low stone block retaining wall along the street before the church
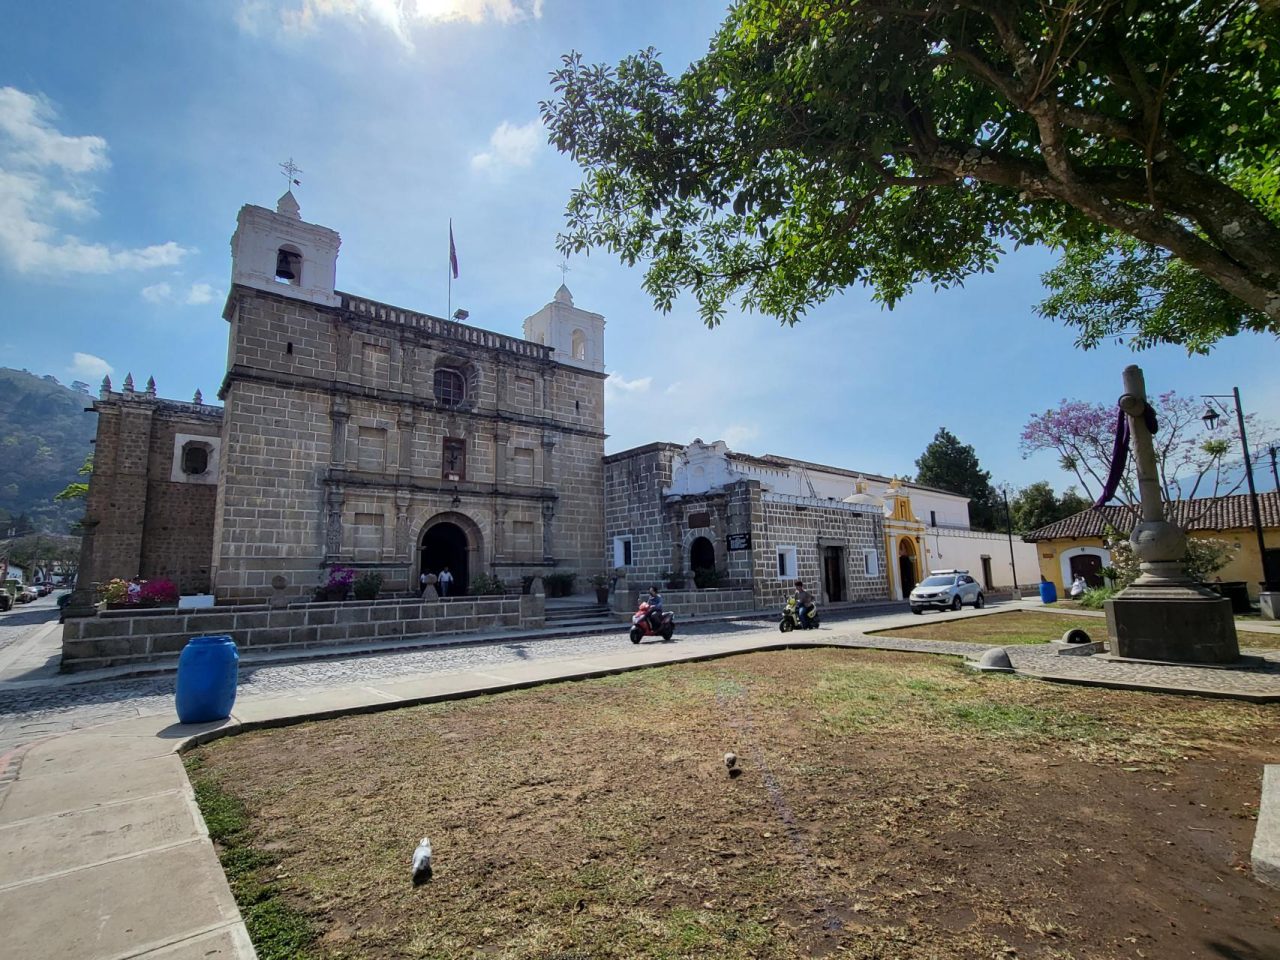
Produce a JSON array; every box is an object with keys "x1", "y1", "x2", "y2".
[{"x1": 61, "y1": 595, "x2": 545, "y2": 672}]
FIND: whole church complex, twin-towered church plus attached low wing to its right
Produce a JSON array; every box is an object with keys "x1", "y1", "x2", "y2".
[{"x1": 81, "y1": 192, "x2": 1034, "y2": 608}]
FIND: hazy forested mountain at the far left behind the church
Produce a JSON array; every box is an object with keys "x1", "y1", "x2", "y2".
[{"x1": 0, "y1": 367, "x2": 97, "y2": 536}]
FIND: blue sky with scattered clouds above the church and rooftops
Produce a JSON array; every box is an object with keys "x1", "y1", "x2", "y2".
[{"x1": 0, "y1": 0, "x2": 1280, "y2": 489}]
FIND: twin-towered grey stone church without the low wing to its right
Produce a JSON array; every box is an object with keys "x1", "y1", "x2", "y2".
[{"x1": 81, "y1": 192, "x2": 605, "y2": 603}]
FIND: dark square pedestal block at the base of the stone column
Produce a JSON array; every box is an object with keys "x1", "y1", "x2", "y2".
[{"x1": 1103, "y1": 577, "x2": 1240, "y2": 663}]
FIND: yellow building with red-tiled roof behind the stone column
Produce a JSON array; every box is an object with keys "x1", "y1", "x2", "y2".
[{"x1": 1023, "y1": 492, "x2": 1280, "y2": 599}]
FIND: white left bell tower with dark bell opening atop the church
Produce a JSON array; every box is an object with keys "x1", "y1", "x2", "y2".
[{"x1": 232, "y1": 191, "x2": 342, "y2": 307}]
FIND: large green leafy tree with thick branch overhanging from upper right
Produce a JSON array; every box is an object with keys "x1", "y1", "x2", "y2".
[{"x1": 541, "y1": 0, "x2": 1280, "y2": 349}]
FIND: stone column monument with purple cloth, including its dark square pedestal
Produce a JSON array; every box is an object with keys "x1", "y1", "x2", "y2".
[{"x1": 1105, "y1": 366, "x2": 1240, "y2": 664}]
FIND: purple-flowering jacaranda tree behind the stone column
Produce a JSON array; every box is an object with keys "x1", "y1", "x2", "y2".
[{"x1": 1020, "y1": 390, "x2": 1275, "y2": 504}]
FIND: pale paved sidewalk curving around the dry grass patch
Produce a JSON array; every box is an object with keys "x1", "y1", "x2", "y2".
[{"x1": 0, "y1": 604, "x2": 1280, "y2": 960}]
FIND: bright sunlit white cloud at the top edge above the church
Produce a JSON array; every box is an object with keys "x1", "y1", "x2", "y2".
[{"x1": 272, "y1": 0, "x2": 543, "y2": 50}]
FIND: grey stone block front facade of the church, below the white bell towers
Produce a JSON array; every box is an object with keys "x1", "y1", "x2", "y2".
[{"x1": 215, "y1": 288, "x2": 604, "y2": 602}]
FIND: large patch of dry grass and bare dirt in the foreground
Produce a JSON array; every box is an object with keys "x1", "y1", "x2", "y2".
[{"x1": 183, "y1": 647, "x2": 1280, "y2": 960}]
